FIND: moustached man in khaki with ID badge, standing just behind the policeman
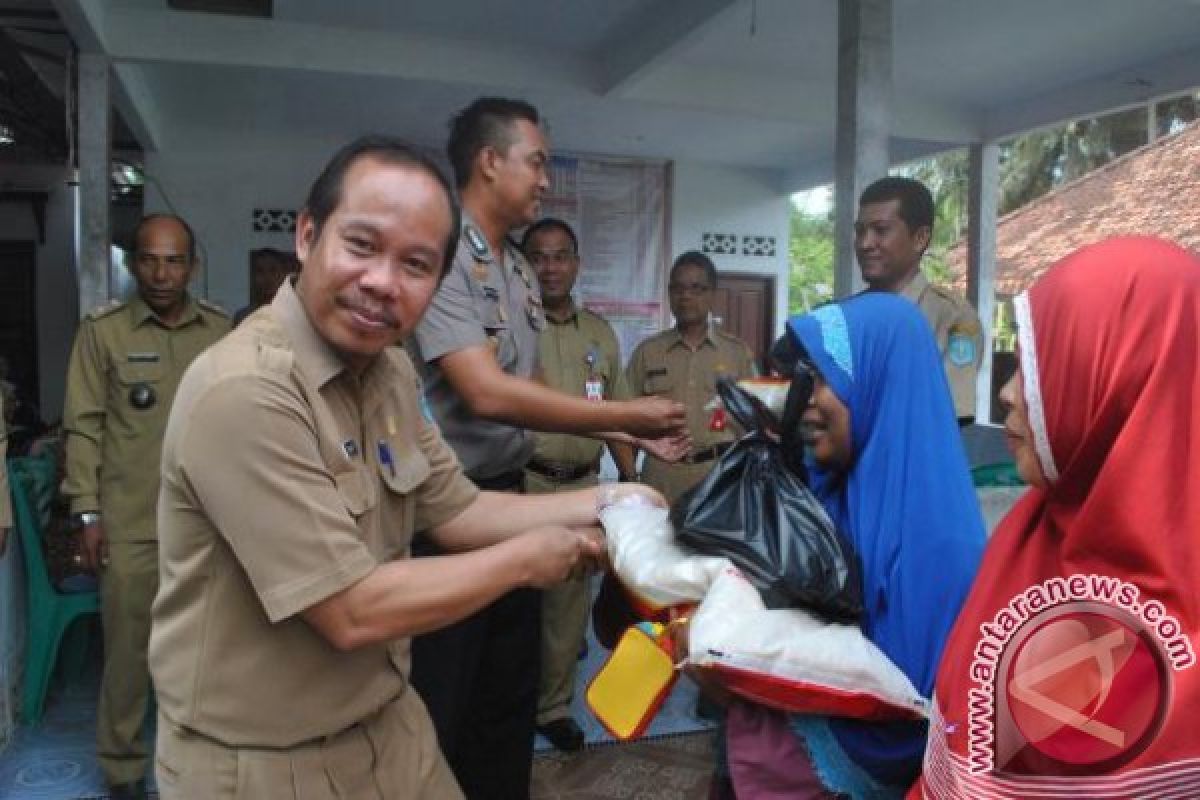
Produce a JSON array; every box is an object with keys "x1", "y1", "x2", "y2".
[{"x1": 521, "y1": 217, "x2": 634, "y2": 752}]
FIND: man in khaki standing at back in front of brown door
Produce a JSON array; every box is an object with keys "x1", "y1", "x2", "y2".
[{"x1": 626, "y1": 251, "x2": 755, "y2": 504}]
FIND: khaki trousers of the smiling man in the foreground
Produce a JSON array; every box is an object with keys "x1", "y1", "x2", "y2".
[{"x1": 155, "y1": 687, "x2": 463, "y2": 800}]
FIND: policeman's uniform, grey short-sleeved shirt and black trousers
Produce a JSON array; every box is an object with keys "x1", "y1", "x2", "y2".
[{"x1": 409, "y1": 213, "x2": 546, "y2": 800}]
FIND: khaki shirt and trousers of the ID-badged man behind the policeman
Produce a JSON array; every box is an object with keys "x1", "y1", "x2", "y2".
[{"x1": 526, "y1": 303, "x2": 629, "y2": 726}]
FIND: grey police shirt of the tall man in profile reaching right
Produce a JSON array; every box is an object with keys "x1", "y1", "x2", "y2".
[{"x1": 408, "y1": 215, "x2": 546, "y2": 480}]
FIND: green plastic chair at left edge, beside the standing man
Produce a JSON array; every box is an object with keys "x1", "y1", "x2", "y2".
[{"x1": 8, "y1": 457, "x2": 100, "y2": 724}]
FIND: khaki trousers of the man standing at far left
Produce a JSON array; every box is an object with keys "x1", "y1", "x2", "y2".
[{"x1": 96, "y1": 541, "x2": 158, "y2": 784}]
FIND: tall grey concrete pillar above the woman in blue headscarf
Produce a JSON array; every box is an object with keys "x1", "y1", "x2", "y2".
[{"x1": 833, "y1": 0, "x2": 892, "y2": 297}]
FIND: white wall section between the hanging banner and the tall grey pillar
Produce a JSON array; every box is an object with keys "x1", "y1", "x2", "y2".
[{"x1": 671, "y1": 162, "x2": 788, "y2": 336}]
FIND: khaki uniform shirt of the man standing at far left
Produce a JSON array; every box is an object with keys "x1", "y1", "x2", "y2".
[{"x1": 62, "y1": 295, "x2": 229, "y2": 542}]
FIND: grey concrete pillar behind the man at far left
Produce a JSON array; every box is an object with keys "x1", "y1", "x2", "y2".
[{"x1": 77, "y1": 53, "x2": 113, "y2": 317}]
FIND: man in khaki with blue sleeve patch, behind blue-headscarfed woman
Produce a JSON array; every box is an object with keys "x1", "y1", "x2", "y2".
[{"x1": 854, "y1": 178, "x2": 983, "y2": 425}]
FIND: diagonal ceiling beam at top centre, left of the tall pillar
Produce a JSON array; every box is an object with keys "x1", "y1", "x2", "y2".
[{"x1": 596, "y1": 0, "x2": 739, "y2": 96}]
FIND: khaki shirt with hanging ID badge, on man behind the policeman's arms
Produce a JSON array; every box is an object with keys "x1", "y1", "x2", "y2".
[{"x1": 534, "y1": 303, "x2": 629, "y2": 467}]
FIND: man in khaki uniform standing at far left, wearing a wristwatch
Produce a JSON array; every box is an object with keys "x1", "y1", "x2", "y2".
[{"x1": 62, "y1": 215, "x2": 229, "y2": 798}]
